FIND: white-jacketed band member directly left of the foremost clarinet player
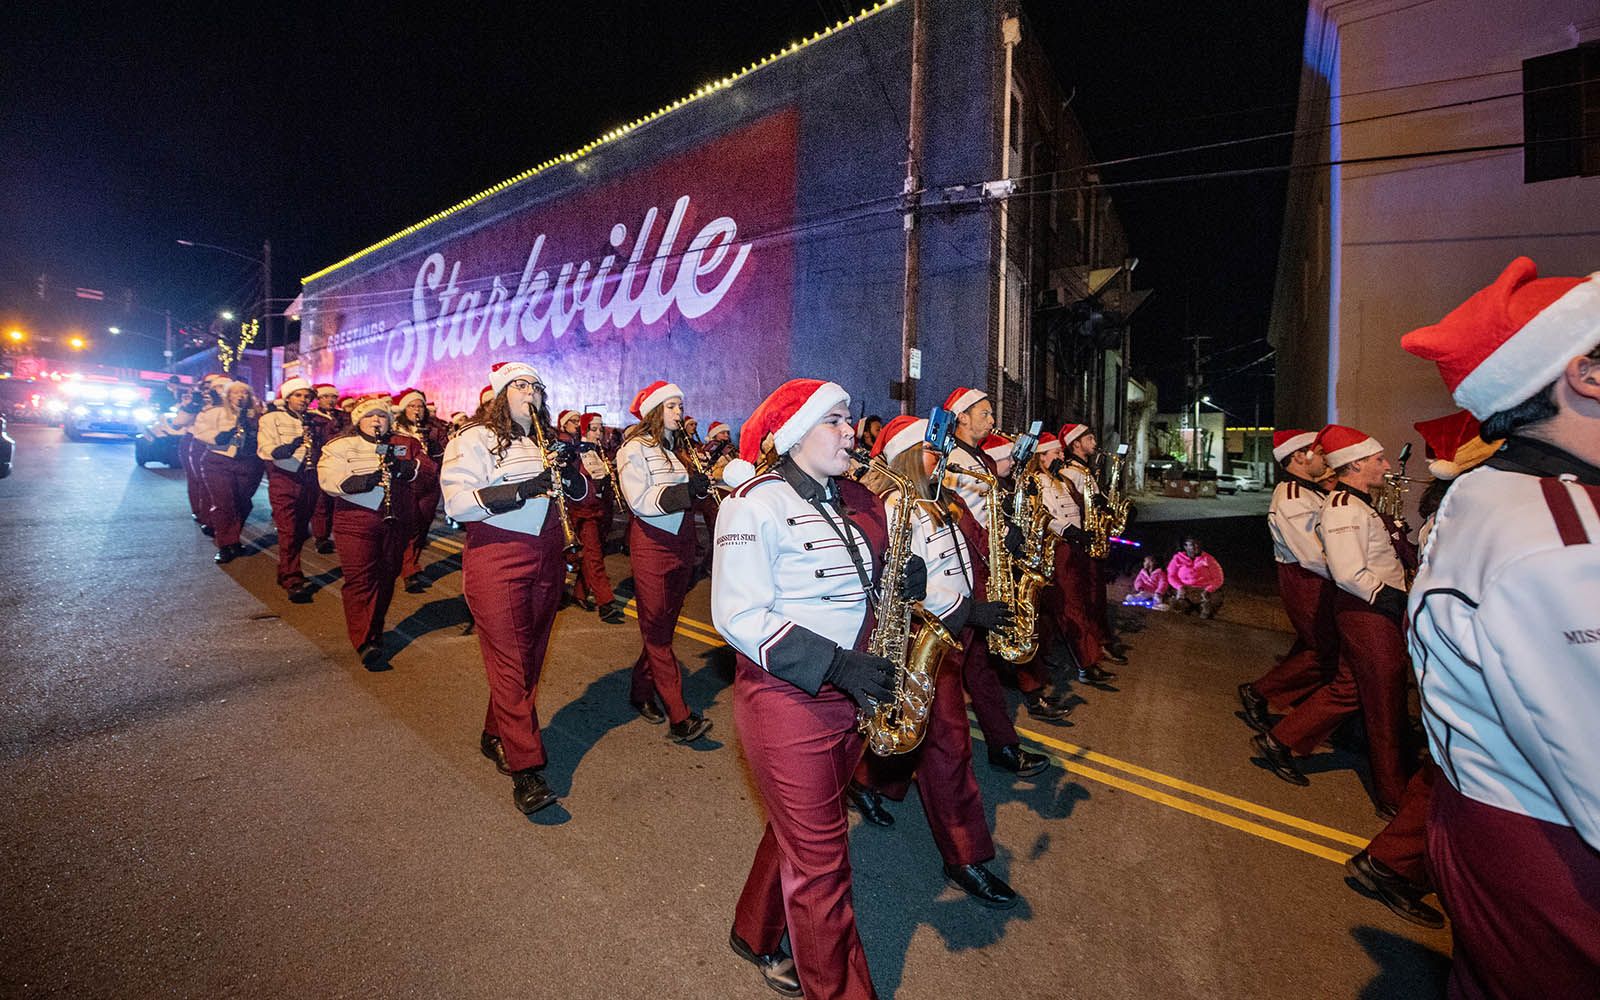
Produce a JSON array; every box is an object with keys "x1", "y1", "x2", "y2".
[{"x1": 256, "y1": 378, "x2": 330, "y2": 605}]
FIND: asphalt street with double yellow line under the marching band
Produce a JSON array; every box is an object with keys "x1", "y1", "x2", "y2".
[{"x1": 0, "y1": 427, "x2": 1450, "y2": 1000}]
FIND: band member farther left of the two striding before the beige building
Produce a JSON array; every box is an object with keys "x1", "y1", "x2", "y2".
[{"x1": 1238, "y1": 430, "x2": 1339, "y2": 733}]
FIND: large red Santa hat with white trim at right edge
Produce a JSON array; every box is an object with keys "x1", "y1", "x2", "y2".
[{"x1": 1400, "y1": 258, "x2": 1600, "y2": 421}]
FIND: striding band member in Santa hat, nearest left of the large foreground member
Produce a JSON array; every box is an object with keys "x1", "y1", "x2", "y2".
[{"x1": 1251, "y1": 424, "x2": 1414, "y2": 819}]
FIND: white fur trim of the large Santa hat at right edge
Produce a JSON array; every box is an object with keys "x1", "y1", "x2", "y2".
[{"x1": 1454, "y1": 270, "x2": 1600, "y2": 421}]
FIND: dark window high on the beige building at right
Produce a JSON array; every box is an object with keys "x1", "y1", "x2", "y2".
[{"x1": 1522, "y1": 43, "x2": 1600, "y2": 184}]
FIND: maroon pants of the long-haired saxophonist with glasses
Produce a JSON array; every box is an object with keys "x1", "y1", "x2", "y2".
[{"x1": 461, "y1": 504, "x2": 566, "y2": 771}]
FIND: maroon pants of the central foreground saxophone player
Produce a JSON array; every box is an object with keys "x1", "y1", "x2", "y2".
[{"x1": 733, "y1": 654, "x2": 877, "y2": 1000}]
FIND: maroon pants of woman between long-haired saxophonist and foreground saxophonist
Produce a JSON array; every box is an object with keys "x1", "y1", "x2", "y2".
[{"x1": 627, "y1": 507, "x2": 694, "y2": 723}]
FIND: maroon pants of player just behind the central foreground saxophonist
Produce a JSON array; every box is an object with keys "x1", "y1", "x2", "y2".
[{"x1": 856, "y1": 629, "x2": 995, "y2": 864}]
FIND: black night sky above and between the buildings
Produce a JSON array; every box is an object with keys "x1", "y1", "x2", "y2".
[{"x1": 0, "y1": 0, "x2": 1306, "y2": 412}]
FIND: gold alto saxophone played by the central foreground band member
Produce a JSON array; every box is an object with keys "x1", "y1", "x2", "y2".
[{"x1": 856, "y1": 461, "x2": 960, "y2": 757}]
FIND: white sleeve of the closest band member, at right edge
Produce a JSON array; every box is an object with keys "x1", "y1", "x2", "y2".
[{"x1": 1472, "y1": 544, "x2": 1600, "y2": 850}]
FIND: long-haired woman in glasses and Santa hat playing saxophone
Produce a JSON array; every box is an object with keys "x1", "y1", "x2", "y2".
[{"x1": 440, "y1": 362, "x2": 586, "y2": 813}]
